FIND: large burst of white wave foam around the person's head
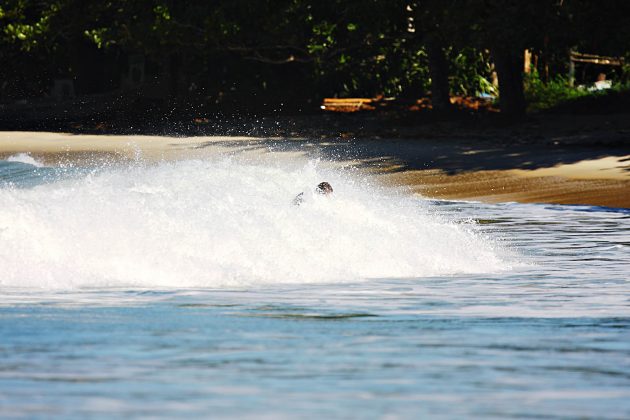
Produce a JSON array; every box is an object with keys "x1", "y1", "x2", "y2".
[{"x1": 0, "y1": 155, "x2": 509, "y2": 289}]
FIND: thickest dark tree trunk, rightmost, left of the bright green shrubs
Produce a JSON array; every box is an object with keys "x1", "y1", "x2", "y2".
[{"x1": 493, "y1": 49, "x2": 525, "y2": 117}]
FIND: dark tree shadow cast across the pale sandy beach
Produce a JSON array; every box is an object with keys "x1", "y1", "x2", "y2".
[{"x1": 173, "y1": 134, "x2": 630, "y2": 175}]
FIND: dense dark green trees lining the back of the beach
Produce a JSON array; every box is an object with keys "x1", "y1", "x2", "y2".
[{"x1": 0, "y1": 0, "x2": 630, "y2": 115}]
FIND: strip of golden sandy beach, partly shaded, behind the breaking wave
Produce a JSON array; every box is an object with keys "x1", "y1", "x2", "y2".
[{"x1": 0, "y1": 131, "x2": 630, "y2": 208}]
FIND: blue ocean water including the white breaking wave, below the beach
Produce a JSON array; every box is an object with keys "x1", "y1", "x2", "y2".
[{"x1": 0, "y1": 150, "x2": 630, "y2": 419}]
